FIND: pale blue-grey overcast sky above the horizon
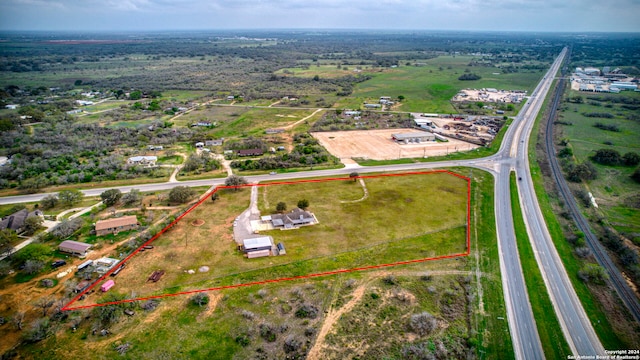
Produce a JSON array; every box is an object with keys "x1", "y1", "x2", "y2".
[{"x1": 0, "y1": 0, "x2": 640, "y2": 32}]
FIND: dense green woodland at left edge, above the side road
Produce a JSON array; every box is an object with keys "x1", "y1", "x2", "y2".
[{"x1": 0, "y1": 121, "x2": 200, "y2": 191}]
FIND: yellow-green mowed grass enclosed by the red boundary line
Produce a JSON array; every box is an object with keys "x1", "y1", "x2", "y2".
[{"x1": 87, "y1": 174, "x2": 467, "y2": 305}]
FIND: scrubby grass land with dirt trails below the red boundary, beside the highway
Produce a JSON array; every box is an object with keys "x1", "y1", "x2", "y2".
[{"x1": 12, "y1": 169, "x2": 513, "y2": 360}]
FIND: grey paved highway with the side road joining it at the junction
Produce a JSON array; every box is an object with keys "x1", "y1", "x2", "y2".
[{"x1": 0, "y1": 49, "x2": 604, "y2": 359}]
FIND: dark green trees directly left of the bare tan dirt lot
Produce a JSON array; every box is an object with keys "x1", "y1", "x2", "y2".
[{"x1": 231, "y1": 134, "x2": 337, "y2": 170}]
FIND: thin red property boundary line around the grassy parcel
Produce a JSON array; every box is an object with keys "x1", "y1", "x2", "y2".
[{"x1": 61, "y1": 170, "x2": 471, "y2": 311}]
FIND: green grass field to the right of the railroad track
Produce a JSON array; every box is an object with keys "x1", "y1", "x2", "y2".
[{"x1": 557, "y1": 91, "x2": 640, "y2": 244}]
